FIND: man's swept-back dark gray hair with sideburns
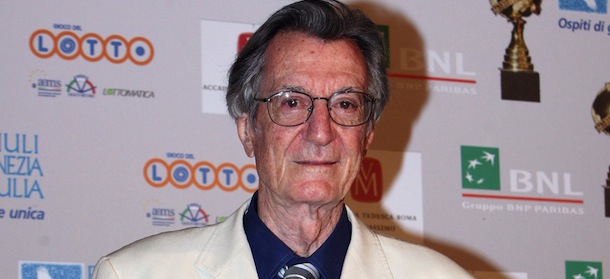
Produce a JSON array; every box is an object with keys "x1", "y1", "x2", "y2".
[{"x1": 226, "y1": 0, "x2": 389, "y2": 126}]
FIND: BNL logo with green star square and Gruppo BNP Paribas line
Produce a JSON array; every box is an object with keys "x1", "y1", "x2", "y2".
[{"x1": 461, "y1": 146, "x2": 584, "y2": 215}]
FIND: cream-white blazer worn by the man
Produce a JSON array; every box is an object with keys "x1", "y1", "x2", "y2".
[{"x1": 93, "y1": 202, "x2": 473, "y2": 279}]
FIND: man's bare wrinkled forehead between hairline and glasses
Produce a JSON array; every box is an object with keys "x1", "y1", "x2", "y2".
[{"x1": 263, "y1": 32, "x2": 367, "y2": 95}]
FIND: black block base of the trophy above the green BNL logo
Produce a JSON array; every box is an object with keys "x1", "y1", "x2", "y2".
[{"x1": 500, "y1": 69, "x2": 540, "y2": 103}]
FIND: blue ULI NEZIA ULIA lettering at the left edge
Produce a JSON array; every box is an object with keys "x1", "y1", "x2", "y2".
[{"x1": 0, "y1": 133, "x2": 44, "y2": 200}]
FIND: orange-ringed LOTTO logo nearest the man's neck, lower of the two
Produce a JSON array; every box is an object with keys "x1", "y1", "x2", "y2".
[{"x1": 144, "y1": 153, "x2": 258, "y2": 193}]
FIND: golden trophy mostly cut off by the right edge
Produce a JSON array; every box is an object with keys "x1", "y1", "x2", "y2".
[{"x1": 591, "y1": 82, "x2": 610, "y2": 217}]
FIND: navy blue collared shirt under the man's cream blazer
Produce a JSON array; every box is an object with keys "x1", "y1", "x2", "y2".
[{"x1": 244, "y1": 192, "x2": 352, "y2": 279}]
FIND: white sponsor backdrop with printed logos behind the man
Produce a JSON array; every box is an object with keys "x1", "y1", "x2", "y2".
[{"x1": 0, "y1": 0, "x2": 610, "y2": 279}]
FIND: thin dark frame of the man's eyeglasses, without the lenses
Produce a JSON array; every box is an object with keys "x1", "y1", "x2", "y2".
[{"x1": 254, "y1": 90, "x2": 377, "y2": 127}]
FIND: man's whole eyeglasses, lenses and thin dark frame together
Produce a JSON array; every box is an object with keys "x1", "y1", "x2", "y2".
[{"x1": 254, "y1": 90, "x2": 376, "y2": 127}]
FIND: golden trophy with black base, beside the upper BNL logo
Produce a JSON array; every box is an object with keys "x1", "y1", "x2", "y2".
[{"x1": 489, "y1": 0, "x2": 542, "y2": 102}]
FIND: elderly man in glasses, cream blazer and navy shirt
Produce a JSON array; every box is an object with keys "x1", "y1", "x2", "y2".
[{"x1": 93, "y1": 0, "x2": 472, "y2": 279}]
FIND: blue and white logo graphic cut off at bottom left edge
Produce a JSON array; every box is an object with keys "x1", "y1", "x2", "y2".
[{"x1": 19, "y1": 262, "x2": 84, "y2": 279}]
